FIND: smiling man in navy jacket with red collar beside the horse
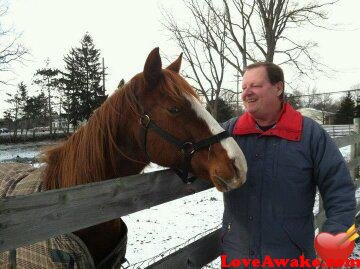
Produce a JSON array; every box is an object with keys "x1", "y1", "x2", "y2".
[{"x1": 222, "y1": 62, "x2": 356, "y2": 268}]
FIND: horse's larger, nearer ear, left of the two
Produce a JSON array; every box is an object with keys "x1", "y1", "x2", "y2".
[{"x1": 143, "y1": 48, "x2": 161, "y2": 87}]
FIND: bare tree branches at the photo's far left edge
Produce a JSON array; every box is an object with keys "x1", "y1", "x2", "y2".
[{"x1": 0, "y1": 0, "x2": 28, "y2": 84}]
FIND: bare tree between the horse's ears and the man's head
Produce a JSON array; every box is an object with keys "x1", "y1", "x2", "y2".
[{"x1": 164, "y1": 1, "x2": 226, "y2": 118}]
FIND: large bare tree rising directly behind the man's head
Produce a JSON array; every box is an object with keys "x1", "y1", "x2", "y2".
[{"x1": 211, "y1": 0, "x2": 336, "y2": 74}]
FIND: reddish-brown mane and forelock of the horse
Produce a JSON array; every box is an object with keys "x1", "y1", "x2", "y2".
[{"x1": 41, "y1": 69, "x2": 199, "y2": 189}]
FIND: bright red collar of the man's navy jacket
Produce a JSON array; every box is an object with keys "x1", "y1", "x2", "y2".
[{"x1": 233, "y1": 103, "x2": 303, "y2": 141}]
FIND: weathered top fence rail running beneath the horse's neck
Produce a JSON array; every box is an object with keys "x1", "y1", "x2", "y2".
[{"x1": 0, "y1": 170, "x2": 212, "y2": 251}]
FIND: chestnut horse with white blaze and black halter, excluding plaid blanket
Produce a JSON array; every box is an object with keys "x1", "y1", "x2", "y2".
[{"x1": 0, "y1": 48, "x2": 247, "y2": 265}]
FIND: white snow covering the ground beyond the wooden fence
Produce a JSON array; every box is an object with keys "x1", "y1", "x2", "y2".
[{"x1": 0, "y1": 141, "x2": 354, "y2": 268}]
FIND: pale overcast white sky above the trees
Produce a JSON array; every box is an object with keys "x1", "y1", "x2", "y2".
[{"x1": 0, "y1": 0, "x2": 360, "y2": 114}]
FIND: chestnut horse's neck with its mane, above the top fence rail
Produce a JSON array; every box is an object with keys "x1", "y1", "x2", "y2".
[{"x1": 45, "y1": 91, "x2": 148, "y2": 189}]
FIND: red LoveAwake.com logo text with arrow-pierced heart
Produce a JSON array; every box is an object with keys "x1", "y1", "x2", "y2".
[{"x1": 221, "y1": 225, "x2": 360, "y2": 268}]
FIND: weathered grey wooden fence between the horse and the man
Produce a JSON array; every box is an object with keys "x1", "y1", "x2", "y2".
[{"x1": 0, "y1": 126, "x2": 360, "y2": 269}]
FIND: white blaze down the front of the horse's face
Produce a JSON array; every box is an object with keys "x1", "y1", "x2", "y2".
[{"x1": 184, "y1": 94, "x2": 247, "y2": 183}]
